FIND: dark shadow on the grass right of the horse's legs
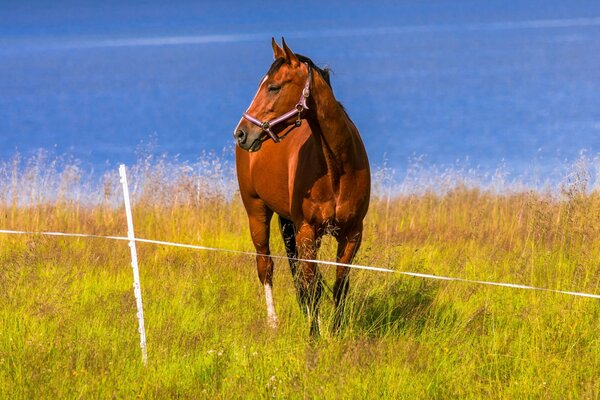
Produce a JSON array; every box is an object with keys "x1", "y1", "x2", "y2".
[{"x1": 347, "y1": 281, "x2": 455, "y2": 337}]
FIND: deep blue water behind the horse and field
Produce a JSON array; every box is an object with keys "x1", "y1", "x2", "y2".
[{"x1": 0, "y1": 0, "x2": 600, "y2": 181}]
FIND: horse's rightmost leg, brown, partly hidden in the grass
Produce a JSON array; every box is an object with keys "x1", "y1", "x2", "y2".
[{"x1": 333, "y1": 229, "x2": 362, "y2": 332}]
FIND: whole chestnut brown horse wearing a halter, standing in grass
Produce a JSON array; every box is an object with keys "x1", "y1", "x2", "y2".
[{"x1": 234, "y1": 39, "x2": 371, "y2": 335}]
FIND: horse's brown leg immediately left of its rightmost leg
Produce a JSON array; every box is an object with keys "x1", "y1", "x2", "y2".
[{"x1": 296, "y1": 223, "x2": 322, "y2": 337}]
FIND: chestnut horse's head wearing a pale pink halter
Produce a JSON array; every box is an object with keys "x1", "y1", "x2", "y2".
[{"x1": 233, "y1": 38, "x2": 312, "y2": 152}]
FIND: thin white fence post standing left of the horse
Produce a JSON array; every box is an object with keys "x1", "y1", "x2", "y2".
[{"x1": 119, "y1": 164, "x2": 148, "y2": 365}]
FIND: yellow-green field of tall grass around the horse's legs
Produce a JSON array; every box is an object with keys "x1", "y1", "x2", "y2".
[{"x1": 0, "y1": 155, "x2": 600, "y2": 399}]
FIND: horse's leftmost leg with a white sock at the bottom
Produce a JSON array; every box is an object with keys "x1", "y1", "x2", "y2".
[{"x1": 247, "y1": 200, "x2": 278, "y2": 329}]
